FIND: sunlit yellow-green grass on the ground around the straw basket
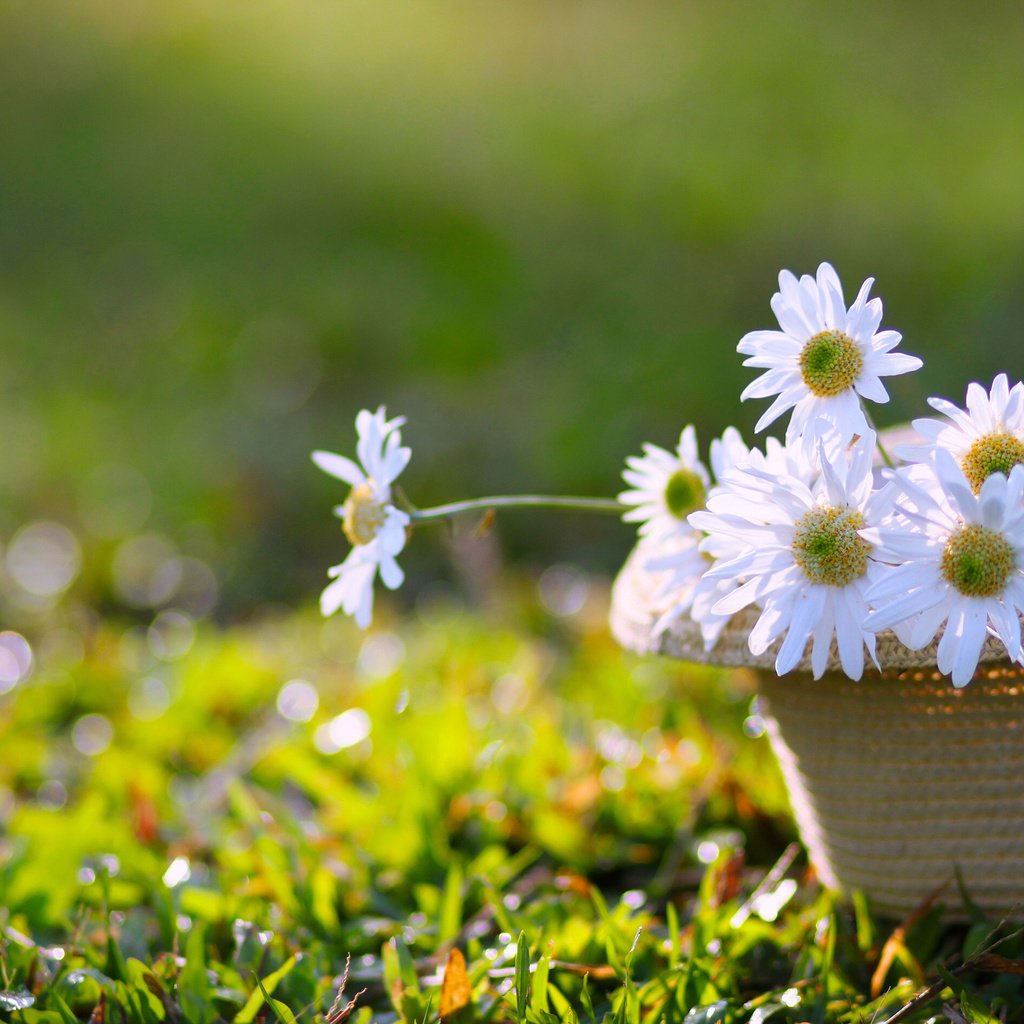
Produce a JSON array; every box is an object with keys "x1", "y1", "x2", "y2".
[{"x1": 0, "y1": 591, "x2": 1024, "y2": 1024}]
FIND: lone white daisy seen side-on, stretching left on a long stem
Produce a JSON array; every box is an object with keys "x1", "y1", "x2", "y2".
[{"x1": 312, "y1": 406, "x2": 412, "y2": 629}]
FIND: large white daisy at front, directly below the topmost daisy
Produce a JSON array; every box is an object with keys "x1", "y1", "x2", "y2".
[{"x1": 690, "y1": 424, "x2": 885, "y2": 679}]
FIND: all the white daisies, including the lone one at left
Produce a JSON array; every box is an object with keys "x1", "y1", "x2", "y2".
[{"x1": 313, "y1": 263, "x2": 1024, "y2": 686}]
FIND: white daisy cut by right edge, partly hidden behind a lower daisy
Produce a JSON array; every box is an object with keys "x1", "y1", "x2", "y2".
[{"x1": 895, "y1": 374, "x2": 1024, "y2": 494}]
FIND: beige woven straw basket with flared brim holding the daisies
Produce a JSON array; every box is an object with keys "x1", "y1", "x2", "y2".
[{"x1": 611, "y1": 553, "x2": 1024, "y2": 920}]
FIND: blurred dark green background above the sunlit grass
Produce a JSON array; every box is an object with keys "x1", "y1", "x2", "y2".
[{"x1": 0, "y1": 0, "x2": 1024, "y2": 625}]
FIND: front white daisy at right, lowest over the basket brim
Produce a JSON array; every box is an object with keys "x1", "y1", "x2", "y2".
[{"x1": 862, "y1": 449, "x2": 1024, "y2": 686}]
